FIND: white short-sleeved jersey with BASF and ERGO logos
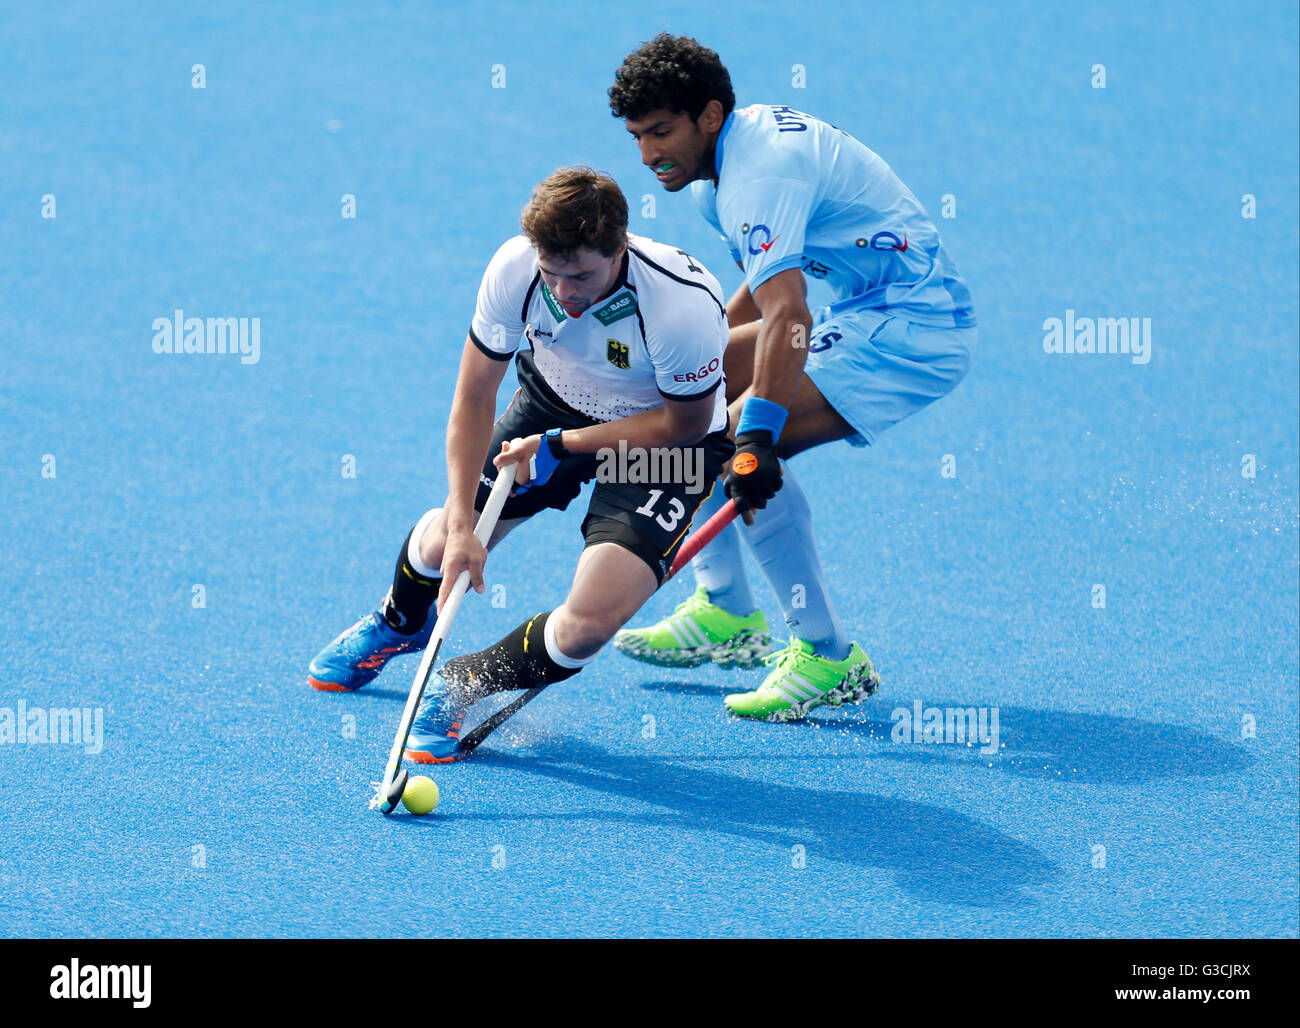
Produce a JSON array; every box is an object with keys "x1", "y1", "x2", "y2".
[{"x1": 469, "y1": 235, "x2": 727, "y2": 431}]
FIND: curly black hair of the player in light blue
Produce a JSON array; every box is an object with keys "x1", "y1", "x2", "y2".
[{"x1": 610, "y1": 32, "x2": 736, "y2": 121}]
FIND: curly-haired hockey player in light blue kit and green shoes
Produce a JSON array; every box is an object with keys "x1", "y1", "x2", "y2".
[{"x1": 610, "y1": 34, "x2": 976, "y2": 720}]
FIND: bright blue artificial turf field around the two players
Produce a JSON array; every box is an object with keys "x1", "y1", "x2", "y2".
[{"x1": 0, "y1": 0, "x2": 1300, "y2": 936}]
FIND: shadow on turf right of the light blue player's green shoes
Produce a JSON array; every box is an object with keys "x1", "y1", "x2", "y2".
[{"x1": 641, "y1": 681, "x2": 1255, "y2": 782}]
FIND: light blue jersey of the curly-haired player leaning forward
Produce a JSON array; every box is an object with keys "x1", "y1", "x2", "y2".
[{"x1": 690, "y1": 104, "x2": 975, "y2": 328}]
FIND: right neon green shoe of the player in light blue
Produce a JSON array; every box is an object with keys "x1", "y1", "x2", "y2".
[{"x1": 723, "y1": 639, "x2": 880, "y2": 721}]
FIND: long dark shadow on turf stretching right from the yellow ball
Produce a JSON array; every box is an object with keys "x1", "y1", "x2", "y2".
[{"x1": 447, "y1": 736, "x2": 1061, "y2": 908}]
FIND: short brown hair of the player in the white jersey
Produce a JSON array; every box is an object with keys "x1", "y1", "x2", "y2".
[{"x1": 519, "y1": 166, "x2": 628, "y2": 260}]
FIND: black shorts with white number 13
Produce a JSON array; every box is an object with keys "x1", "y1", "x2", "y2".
[{"x1": 475, "y1": 352, "x2": 736, "y2": 584}]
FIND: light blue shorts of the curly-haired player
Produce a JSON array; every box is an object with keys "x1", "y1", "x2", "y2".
[{"x1": 803, "y1": 307, "x2": 976, "y2": 446}]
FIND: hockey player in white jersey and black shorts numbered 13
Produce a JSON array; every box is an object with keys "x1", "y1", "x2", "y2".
[{"x1": 308, "y1": 168, "x2": 735, "y2": 763}]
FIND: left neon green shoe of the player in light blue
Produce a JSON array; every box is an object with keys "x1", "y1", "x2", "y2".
[{"x1": 614, "y1": 586, "x2": 772, "y2": 668}]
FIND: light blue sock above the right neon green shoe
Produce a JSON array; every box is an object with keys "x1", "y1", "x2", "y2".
[{"x1": 742, "y1": 461, "x2": 849, "y2": 660}]
